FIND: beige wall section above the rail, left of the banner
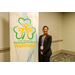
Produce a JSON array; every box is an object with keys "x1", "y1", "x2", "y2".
[{"x1": 0, "y1": 12, "x2": 9, "y2": 48}]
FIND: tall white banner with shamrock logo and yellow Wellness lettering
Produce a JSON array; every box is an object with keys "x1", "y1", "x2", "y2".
[{"x1": 10, "y1": 12, "x2": 39, "y2": 62}]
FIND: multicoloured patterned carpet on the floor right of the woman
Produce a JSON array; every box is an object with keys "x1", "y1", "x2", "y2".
[{"x1": 50, "y1": 53, "x2": 75, "y2": 62}]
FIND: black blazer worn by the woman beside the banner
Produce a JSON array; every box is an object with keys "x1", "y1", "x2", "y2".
[{"x1": 38, "y1": 34, "x2": 52, "y2": 56}]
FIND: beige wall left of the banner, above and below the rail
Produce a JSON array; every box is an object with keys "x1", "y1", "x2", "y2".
[{"x1": 0, "y1": 12, "x2": 10, "y2": 62}]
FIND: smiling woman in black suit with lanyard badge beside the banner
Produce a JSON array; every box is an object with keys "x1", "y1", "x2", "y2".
[{"x1": 39, "y1": 26, "x2": 52, "y2": 62}]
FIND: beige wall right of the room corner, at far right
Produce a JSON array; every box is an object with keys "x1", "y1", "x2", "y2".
[{"x1": 62, "y1": 12, "x2": 75, "y2": 52}]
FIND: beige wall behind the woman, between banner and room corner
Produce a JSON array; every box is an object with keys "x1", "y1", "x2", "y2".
[{"x1": 39, "y1": 12, "x2": 62, "y2": 52}]
